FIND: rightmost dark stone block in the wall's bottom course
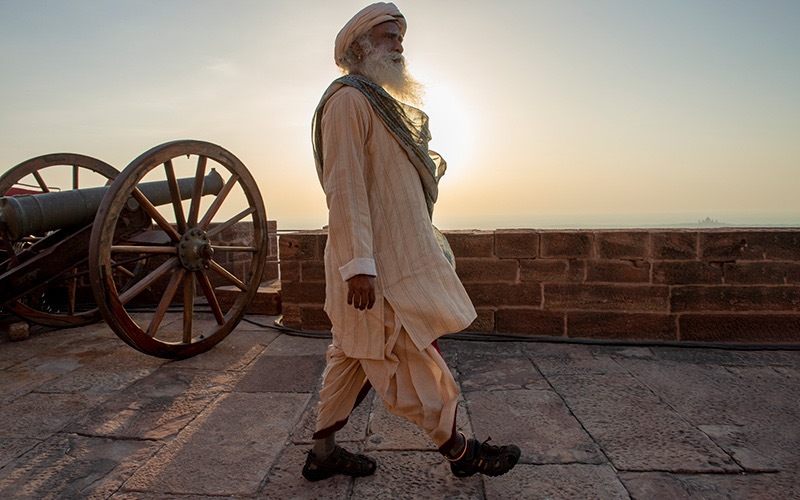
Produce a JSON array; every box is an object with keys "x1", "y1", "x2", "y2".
[{"x1": 678, "y1": 313, "x2": 800, "y2": 343}]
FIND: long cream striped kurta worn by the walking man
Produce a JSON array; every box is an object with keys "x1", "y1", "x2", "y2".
[{"x1": 322, "y1": 86, "x2": 476, "y2": 359}]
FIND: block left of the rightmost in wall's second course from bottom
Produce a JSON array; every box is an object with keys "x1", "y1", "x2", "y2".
[{"x1": 544, "y1": 283, "x2": 669, "y2": 312}]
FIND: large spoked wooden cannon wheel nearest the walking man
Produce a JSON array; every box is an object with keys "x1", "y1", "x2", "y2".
[{"x1": 89, "y1": 140, "x2": 267, "y2": 358}]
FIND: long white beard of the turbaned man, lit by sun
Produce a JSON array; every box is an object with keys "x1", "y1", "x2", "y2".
[{"x1": 358, "y1": 44, "x2": 425, "y2": 106}]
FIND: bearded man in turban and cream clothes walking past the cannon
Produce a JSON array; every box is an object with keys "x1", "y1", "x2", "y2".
[{"x1": 303, "y1": 3, "x2": 520, "y2": 481}]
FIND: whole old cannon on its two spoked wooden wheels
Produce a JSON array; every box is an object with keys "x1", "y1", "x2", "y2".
[{"x1": 0, "y1": 140, "x2": 268, "y2": 358}]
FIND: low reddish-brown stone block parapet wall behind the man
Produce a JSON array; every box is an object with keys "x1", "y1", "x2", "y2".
[{"x1": 279, "y1": 228, "x2": 800, "y2": 343}]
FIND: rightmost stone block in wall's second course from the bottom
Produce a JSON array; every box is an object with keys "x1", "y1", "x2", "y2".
[{"x1": 670, "y1": 285, "x2": 800, "y2": 312}]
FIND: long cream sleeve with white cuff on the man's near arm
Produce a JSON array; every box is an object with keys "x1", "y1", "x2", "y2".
[{"x1": 322, "y1": 92, "x2": 377, "y2": 281}]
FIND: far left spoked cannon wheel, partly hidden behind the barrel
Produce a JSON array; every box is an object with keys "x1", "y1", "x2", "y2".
[{"x1": 0, "y1": 153, "x2": 119, "y2": 327}]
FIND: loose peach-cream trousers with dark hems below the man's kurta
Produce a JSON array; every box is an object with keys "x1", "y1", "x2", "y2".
[{"x1": 314, "y1": 301, "x2": 458, "y2": 452}]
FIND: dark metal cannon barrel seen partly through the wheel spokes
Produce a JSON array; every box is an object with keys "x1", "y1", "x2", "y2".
[{"x1": 0, "y1": 170, "x2": 224, "y2": 240}]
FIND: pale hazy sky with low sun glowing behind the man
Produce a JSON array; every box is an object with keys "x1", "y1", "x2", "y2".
[{"x1": 0, "y1": 0, "x2": 800, "y2": 229}]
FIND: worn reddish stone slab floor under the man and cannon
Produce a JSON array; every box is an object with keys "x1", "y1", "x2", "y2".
[{"x1": 0, "y1": 317, "x2": 800, "y2": 500}]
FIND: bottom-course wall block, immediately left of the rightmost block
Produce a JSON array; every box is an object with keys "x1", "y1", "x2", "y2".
[{"x1": 567, "y1": 311, "x2": 678, "y2": 340}]
